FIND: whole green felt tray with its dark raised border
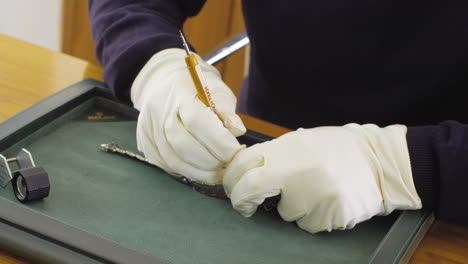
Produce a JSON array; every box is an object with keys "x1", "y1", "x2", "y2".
[{"x1": 0, "y1": 80, "x2": 430, "y2": 264}]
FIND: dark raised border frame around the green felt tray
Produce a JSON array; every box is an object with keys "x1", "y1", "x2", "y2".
[{"x1": 0, "y1": 79, "x2": 433, "y2": 264}]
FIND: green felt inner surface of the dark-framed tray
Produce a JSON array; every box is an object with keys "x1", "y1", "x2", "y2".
[{"x1": 0, "y1": 99, "x2": 395, "y2": 264}]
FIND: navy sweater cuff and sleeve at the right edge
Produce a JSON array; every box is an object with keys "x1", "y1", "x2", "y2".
[{"x1": 407, "y1": 121, "x2": 468, "y2": 225}]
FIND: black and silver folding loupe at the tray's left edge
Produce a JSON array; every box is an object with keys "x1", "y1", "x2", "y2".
[{"x1": 0, "y1": 149, "x2": 50, "y2": 203}]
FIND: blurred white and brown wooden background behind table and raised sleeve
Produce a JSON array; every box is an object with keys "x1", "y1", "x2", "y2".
[{"x1": 0, "y1": 0, "x2": 246, "y2": 95}]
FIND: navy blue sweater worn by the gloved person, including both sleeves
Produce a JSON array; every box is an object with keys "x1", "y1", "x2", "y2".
[{"x1": 89, "y1": 0, "x2": 468, "y2": 224}]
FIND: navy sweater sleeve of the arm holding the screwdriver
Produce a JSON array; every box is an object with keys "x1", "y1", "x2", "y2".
[{"x1": 88, "y1": 0, "x2": 205, "y2": 103}]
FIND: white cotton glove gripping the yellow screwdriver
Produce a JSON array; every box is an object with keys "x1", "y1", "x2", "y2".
[{"x1": 131, "y1": 49, "x2": 246, "y2": 184}]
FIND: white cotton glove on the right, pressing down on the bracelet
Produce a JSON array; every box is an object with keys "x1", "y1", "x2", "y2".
[{"x1": 223, "y1": 124, "x2": 421, "y2": 232}]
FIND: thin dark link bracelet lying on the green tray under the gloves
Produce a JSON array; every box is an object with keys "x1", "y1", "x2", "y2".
[{"x1": 100, "y1": 142, "x2": 279, "y2": 211}]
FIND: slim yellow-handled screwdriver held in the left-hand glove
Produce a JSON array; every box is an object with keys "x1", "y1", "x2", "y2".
[{"x1": 179, "y1": 30, "x2": 222, "y2": 120}]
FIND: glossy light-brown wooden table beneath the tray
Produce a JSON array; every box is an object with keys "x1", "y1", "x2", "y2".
[{"x1": 0, "y1": 34, "x2": 468, "y2": 264}]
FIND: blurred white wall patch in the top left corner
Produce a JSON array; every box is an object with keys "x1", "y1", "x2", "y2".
[{"x1": 0, "y1": 0, "x2": 62, "y2": 52}]
